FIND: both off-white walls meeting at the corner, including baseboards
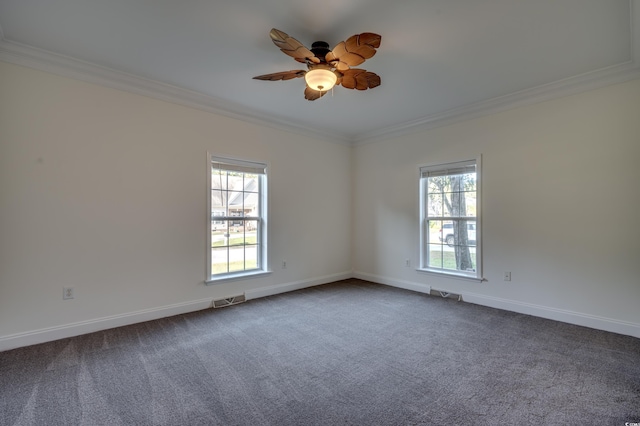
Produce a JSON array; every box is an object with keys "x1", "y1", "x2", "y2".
[{"x1": 0, "y1": 58, "x2": 640, "y2": 350}]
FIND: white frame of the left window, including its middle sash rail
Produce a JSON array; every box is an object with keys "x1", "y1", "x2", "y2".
[{"x1": 205, "y1": 152, "x2": 271, "y2": 285}]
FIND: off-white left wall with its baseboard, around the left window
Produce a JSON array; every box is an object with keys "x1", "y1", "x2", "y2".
[{"x1": 0, "y1": 62, "x2": 351, "y2": 350}]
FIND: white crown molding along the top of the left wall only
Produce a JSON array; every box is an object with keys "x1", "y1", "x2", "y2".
[{"x1": 0, "y1": 37, "x2": 352, "y2": 145}]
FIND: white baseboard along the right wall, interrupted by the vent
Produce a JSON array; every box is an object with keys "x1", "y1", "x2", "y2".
[{"x1": 353, "y1": 272, "x2": 640, "y2": 338}]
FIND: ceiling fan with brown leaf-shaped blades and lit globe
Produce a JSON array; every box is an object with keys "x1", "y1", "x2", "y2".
[{"x1": 253, "y1": 28, "x2": 382, "y2": 101}]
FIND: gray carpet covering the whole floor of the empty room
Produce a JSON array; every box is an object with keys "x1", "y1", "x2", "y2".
[{"x1": 0, "y1": 279, "x2": 640, "y2": 426}]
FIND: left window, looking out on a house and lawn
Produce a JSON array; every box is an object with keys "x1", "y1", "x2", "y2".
[{"x1": 207, "y1": 156, "x2": 267, "y2": 281}]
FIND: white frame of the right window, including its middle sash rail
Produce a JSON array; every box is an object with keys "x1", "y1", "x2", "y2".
[{"x1": 418, "y1": 155, "x2": 484, "y2": 281}]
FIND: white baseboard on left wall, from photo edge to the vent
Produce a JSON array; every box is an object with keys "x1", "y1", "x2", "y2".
[{"x1": 0, "y1": 298, "x2": 213, "y2": 352}]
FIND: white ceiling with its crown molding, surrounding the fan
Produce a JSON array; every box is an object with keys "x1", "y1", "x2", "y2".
[{"x1": 0, "y1": 0, "x2": 640, "y2": 142}]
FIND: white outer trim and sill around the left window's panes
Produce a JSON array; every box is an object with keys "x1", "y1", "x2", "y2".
[{"x1": 204, "y1": 152, "x2": 272, "y2": 285}]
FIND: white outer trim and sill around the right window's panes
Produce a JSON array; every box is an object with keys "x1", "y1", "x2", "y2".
[{"x1": 417, "y1": 155, "x2": 485, "y2": 282}]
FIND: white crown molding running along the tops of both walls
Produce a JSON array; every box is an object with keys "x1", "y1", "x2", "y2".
[{"x1": 0, "y1": 0, "x2": 640, "y2": 145}]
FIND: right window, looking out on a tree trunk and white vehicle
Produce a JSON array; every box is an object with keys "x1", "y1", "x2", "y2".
[{"x1": 420, "y1": 158, "x2": 482, "y2": 279}]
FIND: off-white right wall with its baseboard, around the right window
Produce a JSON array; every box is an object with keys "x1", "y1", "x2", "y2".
[{"x1": 353, "y1": 80, "x2": 640, "y2": 337}]
